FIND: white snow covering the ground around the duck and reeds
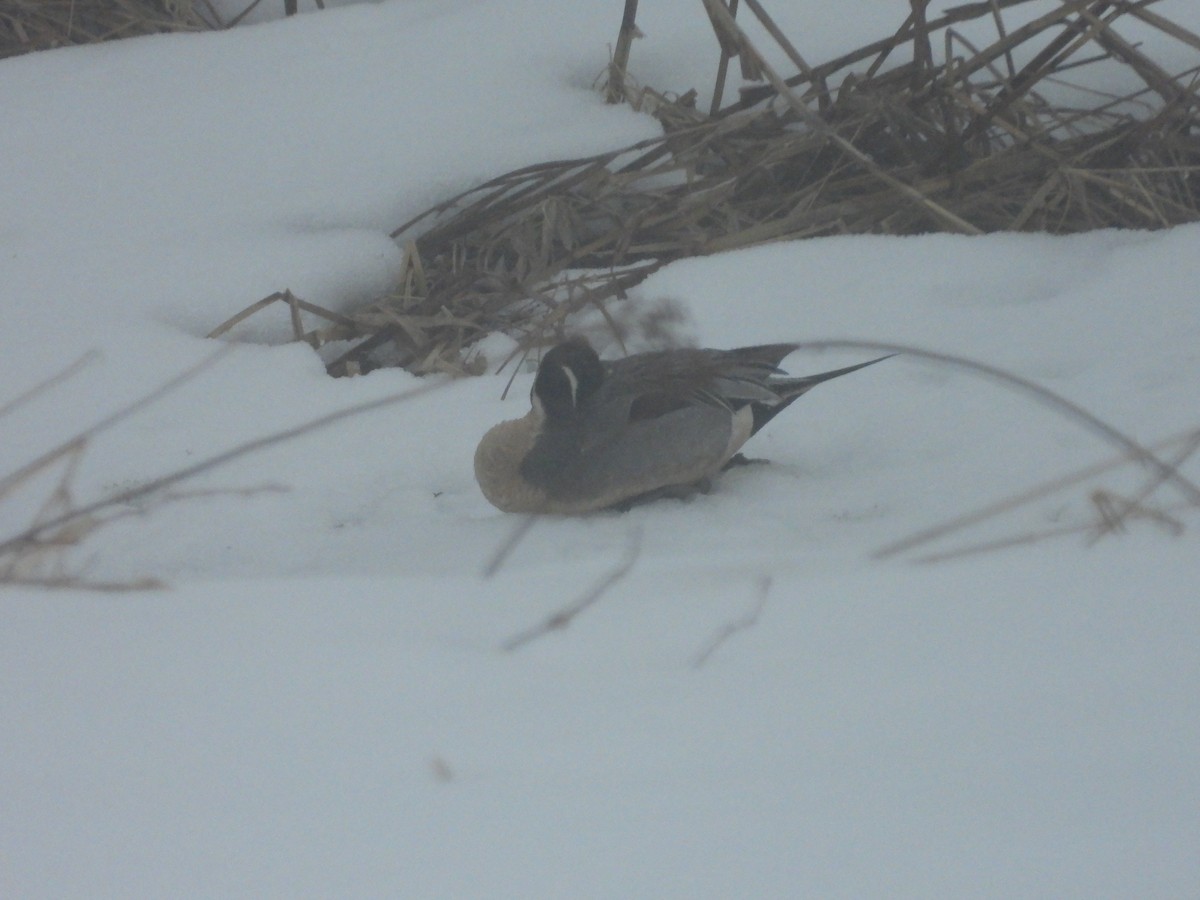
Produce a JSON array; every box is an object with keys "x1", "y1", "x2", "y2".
[{"x1": 0, "y1": 0, "x2": 1200, "y2": 898}]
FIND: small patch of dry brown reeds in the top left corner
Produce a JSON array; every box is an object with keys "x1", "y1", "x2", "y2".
[{"x1": 0, "y1": 0, "x2": 220, "y2": 59}]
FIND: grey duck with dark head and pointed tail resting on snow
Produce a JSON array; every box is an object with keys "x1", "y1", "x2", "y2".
[{"x1": 475, "y1": 336, "x2": 894, "y2": 515}]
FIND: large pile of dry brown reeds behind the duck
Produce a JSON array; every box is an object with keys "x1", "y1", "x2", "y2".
[{"x1": 214, "y1": 0, "x2": 1200, "y2": 374}]
